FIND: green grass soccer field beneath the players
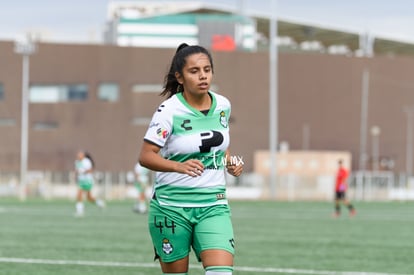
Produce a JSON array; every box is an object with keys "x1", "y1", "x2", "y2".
[{"x1": 0, "y1": 198, "x2": 414, "y2": 275}]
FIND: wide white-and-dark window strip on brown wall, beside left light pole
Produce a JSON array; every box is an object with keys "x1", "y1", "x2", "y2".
[{"x1": 30, "y1": 84, "x2": 88, "y2": 103}]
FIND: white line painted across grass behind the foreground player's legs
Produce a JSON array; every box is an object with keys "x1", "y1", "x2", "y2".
[{"x1": 0, "y1": 257, "x2": 408, "y2": 275}]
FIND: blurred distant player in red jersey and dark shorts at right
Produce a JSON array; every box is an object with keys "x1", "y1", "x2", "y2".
[{"x1": 334, "y1": 159, "x2": 356, "y2": 217}]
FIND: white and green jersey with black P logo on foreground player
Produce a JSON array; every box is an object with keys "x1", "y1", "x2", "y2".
[{"x1": 144, "y1": 91, "x2": 231, "y2": 207}]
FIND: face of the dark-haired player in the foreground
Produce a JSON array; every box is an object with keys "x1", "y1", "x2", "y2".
[{"x1": 176, "y1": 53, "x2": 213, "y2": 96}]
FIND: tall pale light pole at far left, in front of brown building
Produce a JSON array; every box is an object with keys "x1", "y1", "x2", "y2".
[{"x1": 14, "y1": 37, "x2": 36, "y2": 200}]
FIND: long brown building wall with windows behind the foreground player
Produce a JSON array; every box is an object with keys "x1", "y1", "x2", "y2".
[{"x1": 0, "y1": 42, "x2": 414, "y2": 176}]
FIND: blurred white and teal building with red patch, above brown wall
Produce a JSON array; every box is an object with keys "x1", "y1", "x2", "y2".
[{"x1": 105, "y1": 6, "x2": 256, "y2": 51}]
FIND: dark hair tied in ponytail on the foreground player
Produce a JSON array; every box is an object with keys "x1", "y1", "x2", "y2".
[{"x1": 160, "y1": 43, "x2": 214, "y2": 97}]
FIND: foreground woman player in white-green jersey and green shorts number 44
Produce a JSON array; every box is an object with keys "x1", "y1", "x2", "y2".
[{"x1": 139, "y1": 44, "x2": 243, "y2": 275}]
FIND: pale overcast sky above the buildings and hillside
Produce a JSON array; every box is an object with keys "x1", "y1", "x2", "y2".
[{"x1": 0, "y1": 0, "x2": 414, "y2": 43}]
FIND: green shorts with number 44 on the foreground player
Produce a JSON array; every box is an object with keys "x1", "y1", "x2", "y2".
[{"x1": 148, "y1": 199, "x2": 234, "y2": 263}]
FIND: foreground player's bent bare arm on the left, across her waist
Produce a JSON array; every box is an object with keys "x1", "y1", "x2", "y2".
[{"x1": 139, "y1": 141, "x2": 204, "y2": 177}]
